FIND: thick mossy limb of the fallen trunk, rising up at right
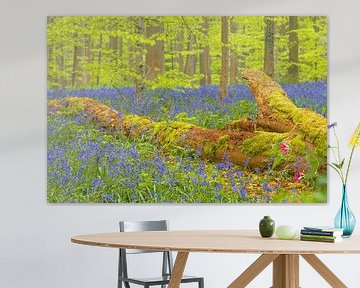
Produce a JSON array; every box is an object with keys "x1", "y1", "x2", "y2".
[{"x1": 224, "y1": 69, "x2": 327, "y2": 164}]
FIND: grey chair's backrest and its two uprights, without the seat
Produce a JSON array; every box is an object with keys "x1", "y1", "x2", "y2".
[{"x1": 119, "y1": 220, "x2": 173, "y2": 277}]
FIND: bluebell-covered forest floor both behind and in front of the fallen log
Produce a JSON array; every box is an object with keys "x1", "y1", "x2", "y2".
[{"x1": 48, "y1": 82, "x2": 327, "y2": 203}]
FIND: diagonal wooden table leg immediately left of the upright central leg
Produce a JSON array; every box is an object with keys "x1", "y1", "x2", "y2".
[{"x1": 228, "y1": 254, "x2": 279, "y2": 288}]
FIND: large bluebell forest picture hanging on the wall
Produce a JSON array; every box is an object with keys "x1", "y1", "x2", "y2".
[{"x1": 47, "y1": 16, "x2": 328, "y2": 204}]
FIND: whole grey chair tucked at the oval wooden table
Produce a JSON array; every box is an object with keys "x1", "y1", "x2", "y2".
[{"x1": 118, "y1": 220, "x2": 204, "y2": 288}]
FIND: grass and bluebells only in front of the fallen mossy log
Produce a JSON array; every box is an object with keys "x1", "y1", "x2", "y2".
[{"x1": 48, "y1": 111, "x2": 326, "y2": 203}]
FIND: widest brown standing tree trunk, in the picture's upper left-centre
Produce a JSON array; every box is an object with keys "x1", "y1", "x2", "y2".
[{"x1": 145, "y1": 17, "x2": 165, "y2": 80}]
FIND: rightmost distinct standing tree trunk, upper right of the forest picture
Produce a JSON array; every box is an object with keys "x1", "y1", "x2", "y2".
[{"x1": 288, "y1": 16, "x2": 299, "y2": 83}]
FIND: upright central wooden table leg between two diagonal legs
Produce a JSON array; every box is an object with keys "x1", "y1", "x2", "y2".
[{"x1": 272, "y1": 254, "x2": 299, "y2": 288}]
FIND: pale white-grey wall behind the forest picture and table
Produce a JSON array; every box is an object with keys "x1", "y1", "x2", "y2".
[{"x1": 0, "y1": 0, "x2": 360, "y2": 288}]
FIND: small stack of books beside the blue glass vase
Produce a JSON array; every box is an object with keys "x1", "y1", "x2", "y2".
[{"x1": 300, "y1": 227, "x2": 344, "y2": 243}]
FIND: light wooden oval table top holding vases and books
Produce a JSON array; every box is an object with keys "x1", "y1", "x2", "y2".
[{"x1": 71, "y1": 230, "x2": 360, "y2": 254}]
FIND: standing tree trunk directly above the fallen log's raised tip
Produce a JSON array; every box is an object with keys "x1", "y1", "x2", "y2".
[{"x1": 264, "y1": 16, "x2": 275, "y2": 78}]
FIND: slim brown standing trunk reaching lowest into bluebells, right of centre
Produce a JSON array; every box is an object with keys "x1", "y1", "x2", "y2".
[{"x1": 219, "y1": 16, "x2": 229, "y2": 102}]
